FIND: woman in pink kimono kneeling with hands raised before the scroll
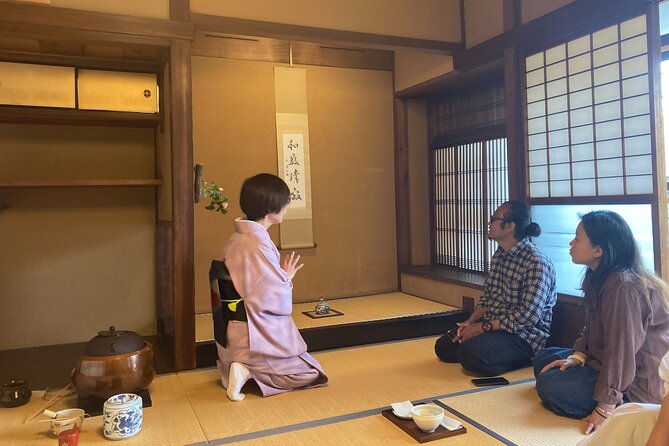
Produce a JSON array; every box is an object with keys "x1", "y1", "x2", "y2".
[{"x1": 216, "y1": 173, "x2": 328, "y2": 401}]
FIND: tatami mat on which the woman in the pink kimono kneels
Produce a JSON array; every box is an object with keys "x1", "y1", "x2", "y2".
[{"x1": 179, "y1": 337, "x2": 532, "y2": 440}]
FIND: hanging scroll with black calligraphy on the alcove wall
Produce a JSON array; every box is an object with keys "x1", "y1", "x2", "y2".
[{"x1": 274, "y1": 67, "x2": 314, "y2": 249}]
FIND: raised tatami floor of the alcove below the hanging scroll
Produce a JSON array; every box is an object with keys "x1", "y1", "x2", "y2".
[{"x1": 195, "y1": 292, "x2": 458, "y2": 342}]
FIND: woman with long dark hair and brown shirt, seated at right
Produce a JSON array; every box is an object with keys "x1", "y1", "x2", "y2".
[{"x1": 534, "y1": 211, "x2": 669, "y2": 434}]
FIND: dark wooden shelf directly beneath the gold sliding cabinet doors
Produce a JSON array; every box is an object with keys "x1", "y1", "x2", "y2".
[{"x1": 0, "y1": 105, "x2": 161, "y2": 128}]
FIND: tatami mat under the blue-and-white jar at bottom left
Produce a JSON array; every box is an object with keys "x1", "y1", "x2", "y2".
[{"x1": 0, "y1": 374, "x2": 206, "y2": 446}]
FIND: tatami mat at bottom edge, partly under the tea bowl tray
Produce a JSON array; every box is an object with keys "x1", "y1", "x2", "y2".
[{"x1": 227, "y1": 415, "x2": 503, "y2": 446}]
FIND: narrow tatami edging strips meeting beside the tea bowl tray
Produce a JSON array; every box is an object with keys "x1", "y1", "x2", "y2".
[{"x1": 188, "y1": 378, "x2": 534, "y2": 446}]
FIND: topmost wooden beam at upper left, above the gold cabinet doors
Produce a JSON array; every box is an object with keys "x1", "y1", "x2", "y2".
[{"x1": 0, "y1": 0, "x2": 193, "y2": 40}]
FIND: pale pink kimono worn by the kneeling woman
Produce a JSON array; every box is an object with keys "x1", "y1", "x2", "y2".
[{"x1": 216, "y1": 218, "x2": 328, "y2": 396}]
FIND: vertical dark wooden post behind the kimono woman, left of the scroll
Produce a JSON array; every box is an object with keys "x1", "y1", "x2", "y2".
[{"x1": 169, "y1": 39, "x2": 195, "y2": 370}]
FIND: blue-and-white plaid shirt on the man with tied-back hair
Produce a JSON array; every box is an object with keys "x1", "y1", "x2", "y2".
[{"x1": 476, "y1": 238, "x2": 557, "y2": 354}]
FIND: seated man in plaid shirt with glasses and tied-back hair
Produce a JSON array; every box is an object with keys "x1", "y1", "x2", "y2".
[{"x1": 434, "y1": 201, "x2": 557, "y2": 376}]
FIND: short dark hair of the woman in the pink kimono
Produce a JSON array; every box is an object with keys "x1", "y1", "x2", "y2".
[{"x1": 239, "y1": 173, "x2": 290, "y2": 221}]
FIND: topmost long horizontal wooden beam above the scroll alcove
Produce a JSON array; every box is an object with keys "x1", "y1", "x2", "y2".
[{"x1": 191, "y1": 14, "x2": 464, "y2": 54}]
